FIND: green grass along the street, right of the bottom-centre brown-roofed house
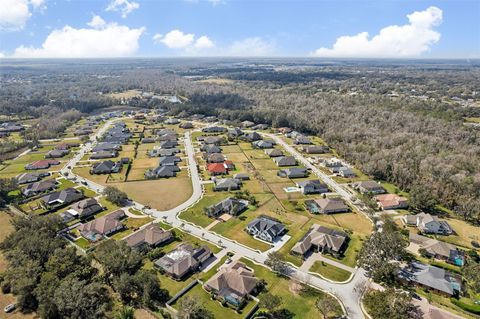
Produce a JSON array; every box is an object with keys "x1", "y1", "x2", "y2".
[{"x1": 241, "y1": 258, "x2": 342, "y2": 318}]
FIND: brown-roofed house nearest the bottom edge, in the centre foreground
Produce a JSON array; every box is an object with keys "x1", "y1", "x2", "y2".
[{"x1": 203, "y1": 261, "x2": 258, "y2": 307}]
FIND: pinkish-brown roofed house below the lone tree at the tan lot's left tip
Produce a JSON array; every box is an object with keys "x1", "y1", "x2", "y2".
[{"x1": 77, "y1": 209, "x2": 127, "y2": 242}]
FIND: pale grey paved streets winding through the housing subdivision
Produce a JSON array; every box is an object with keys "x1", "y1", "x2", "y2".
[{"x1": 61, "y1": 119, "x2": 366, "y2": 319}]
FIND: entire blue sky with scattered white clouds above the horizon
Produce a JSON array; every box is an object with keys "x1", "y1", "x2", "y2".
[{"x1": 0, "y1": 0, "x2": 480, "y2": 58}]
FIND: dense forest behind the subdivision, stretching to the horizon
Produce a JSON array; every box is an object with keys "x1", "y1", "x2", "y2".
[{"x1": 0, "y1": 59, "x2": 480, "y2": 224}]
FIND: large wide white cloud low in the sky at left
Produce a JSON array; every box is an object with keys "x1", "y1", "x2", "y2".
[{"x1": 13, "y1": 18, "x2": 145, "y2": 58}]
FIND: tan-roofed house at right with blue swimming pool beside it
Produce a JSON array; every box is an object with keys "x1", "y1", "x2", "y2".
[{"x1": 409, "y1": 232, "x2": 464, "y2": 267}]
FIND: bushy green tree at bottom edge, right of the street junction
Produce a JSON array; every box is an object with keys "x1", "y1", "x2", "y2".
[{"x1": 363, "y1": 288, "x2": 423, "y2": 319}]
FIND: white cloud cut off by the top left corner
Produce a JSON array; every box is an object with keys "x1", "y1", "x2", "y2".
[{"x1": 0, "y1": 0, "x2": 32, "y2": 31}]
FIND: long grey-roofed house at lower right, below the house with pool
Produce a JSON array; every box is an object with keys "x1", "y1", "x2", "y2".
[{"x1": 398, "y1": 262, "x2": 462, "y2": 297}]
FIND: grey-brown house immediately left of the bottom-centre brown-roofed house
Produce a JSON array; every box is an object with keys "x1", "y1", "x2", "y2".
[{"x1": 154, "y1": 244, "x2": 213, "y2": 279}]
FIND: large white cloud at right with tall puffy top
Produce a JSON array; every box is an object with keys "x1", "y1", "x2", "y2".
[{"x1": 312, "y1": 7, "x2": 442, "y2": 58}]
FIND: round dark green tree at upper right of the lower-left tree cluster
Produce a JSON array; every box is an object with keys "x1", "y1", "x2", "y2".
[{"x1": 94, "y1": 240, "x2": 142, "y2": 277}]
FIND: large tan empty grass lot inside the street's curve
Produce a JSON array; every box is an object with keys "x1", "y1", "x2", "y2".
[{"x1": 109, "y1": 177, "x2": 192, "y2": 210}]
